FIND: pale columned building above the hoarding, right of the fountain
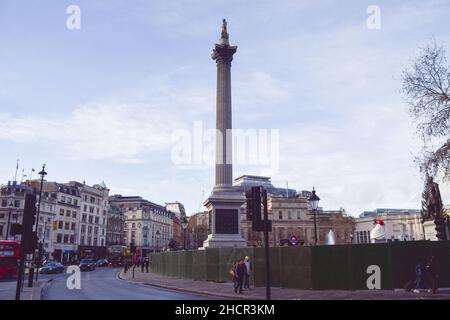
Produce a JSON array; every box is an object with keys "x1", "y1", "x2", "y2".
[{"x1": 354, "y1": 209, "x2": 424, "y2": 243}]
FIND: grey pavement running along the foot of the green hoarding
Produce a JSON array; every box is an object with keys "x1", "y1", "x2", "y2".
[{"x1": 118, "y1": 268, "x2": 450, "y2": 300}]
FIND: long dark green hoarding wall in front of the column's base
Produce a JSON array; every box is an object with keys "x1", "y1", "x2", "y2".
[{"x1": 151, "y1": 241, "x2": 450, "y2": 290}]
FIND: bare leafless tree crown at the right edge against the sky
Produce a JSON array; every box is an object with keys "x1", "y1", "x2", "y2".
[{"x1": 402, "y1": 41, "x2": 450, "y2": 179}]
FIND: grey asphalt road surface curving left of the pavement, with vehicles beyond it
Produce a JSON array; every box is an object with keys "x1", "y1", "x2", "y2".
[{"x1": 40, "y1": 268, "x2": 221, "y2": 300}]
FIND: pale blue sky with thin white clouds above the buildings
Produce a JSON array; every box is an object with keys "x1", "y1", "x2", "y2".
[{"x1": 0, "y1": 0, "x2": 450, "y2": 216}]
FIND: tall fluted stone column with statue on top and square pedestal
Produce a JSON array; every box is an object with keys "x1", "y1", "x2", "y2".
[{"x1": 203, "y1": 19, "x2": 247, "y2": 248}]
